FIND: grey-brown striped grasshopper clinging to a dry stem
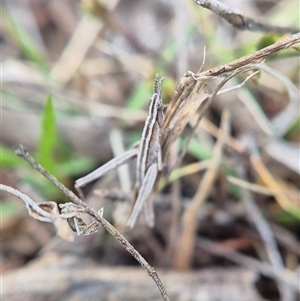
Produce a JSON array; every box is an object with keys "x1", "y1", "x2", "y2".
[{"x1": 75, "y1": 74, "x2": 164, "y2": 227}]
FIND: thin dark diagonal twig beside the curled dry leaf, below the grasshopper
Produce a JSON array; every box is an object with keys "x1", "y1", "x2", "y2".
[{"x1": 16, "y1": 145, "x2": 170, "y2": 301}]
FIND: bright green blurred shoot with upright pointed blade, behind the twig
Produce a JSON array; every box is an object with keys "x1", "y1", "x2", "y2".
[{"x1": 0, "y1": 95, "x2": 94, "y2": 200}]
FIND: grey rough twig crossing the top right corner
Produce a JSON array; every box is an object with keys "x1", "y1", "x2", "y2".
[{"x1": 194, "y1": 0, "x2": 299, "y2": 34}]
